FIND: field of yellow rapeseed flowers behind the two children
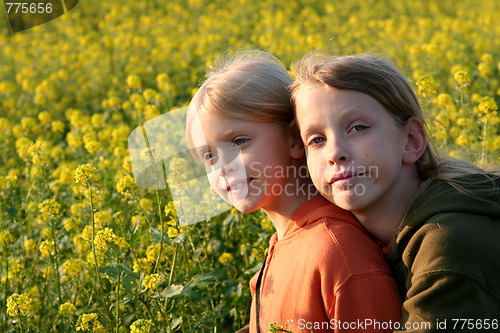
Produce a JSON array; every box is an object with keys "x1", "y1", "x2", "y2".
[{"x1": 0, "y1": 0, "x2": 500, "y2": 333}]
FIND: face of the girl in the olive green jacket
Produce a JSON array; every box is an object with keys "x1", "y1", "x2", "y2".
[{"x1": 295, "y1": 84, "x2": 408, "y2": 218}]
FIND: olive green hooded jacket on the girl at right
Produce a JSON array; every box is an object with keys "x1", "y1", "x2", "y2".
[{"x1": 388, "y1": 175, "x2": 500, "y2": 332}]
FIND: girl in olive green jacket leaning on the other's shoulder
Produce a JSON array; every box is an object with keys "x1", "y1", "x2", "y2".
[{"x1": 292, "y1": 54, "x2": 500, "y2": 332}]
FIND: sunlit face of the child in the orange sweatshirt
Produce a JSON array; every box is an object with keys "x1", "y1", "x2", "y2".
[{"x1": 191, "y1": 112, "x2": 300, "y2": 213}]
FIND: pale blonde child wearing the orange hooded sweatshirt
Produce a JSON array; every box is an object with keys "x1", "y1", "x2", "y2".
[{"x1": 186, "y1": 52, "x2": 401, "y2": 333}]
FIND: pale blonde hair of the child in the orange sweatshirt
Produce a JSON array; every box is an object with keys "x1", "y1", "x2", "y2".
[{"x1": 186, "y1": 51, "x2": 296, "y2": 156}]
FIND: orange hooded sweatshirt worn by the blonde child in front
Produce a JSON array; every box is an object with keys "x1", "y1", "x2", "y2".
[{"x1": 250, "y1": 196, "x2": 401, "y2": 333}]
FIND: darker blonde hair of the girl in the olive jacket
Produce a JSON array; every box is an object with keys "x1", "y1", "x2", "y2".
[{"x1": 291, "y1": 53, "x2": 494, "y2": 181}]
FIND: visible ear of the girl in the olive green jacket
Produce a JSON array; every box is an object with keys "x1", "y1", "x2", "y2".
[{"x1": 403, "y1": 117, "x2": 427, "y2": 164}]
